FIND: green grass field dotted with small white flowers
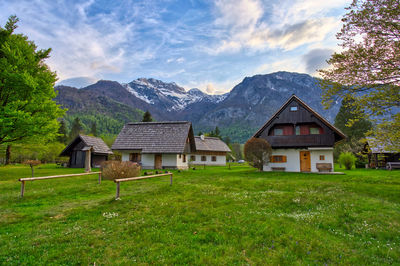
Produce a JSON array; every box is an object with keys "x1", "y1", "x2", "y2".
[{"x1": 0, "y1": 165, "x2": 400, "y2": 265}]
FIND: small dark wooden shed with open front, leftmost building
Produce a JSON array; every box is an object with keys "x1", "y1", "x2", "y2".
[{"x1": 60, "y1": 135, "x2": 113, "y2": 168}]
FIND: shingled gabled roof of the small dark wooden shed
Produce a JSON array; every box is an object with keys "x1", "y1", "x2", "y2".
[{"x1": 60, "y1": 135, "x2": 113, "y2": 156}]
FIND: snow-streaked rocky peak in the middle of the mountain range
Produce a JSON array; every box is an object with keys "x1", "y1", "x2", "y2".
[{"x1": 122, "y1": 78, "x2": 227, "y2": 112}]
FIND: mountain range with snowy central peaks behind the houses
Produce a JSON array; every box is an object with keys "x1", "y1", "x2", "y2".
[{"x1": 56, "y1": 71, "x2": 340, "y2": 143}]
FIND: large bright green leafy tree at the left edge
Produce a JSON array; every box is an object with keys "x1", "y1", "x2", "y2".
[{"x1": 0, "y1": 16, "x2": 64, "y2": 144}]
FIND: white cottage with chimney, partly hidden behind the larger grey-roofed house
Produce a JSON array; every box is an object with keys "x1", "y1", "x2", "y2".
[{"x1": 190, "y1": 136, "x2": 231, "y2": 165}]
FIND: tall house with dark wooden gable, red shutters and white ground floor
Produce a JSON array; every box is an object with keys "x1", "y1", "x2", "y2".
[{"x1": 253, "y1": 95, "x2": 346, "y2": 172}]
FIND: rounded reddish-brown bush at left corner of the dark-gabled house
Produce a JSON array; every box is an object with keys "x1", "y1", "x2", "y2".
[{"x1": 244, "y1": 138, "x2": 272, "y2": 171}]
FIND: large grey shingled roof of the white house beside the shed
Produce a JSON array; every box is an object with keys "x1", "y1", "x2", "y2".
[{"x1": 112, "y1": 121, "x2": 195, "y2": 153}]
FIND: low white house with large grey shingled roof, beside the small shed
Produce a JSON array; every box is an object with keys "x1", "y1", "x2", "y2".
[{"x1": 111, "y1": 121, "x2": 196, "y2": 169}]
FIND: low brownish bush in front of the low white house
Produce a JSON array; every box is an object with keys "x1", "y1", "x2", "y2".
[{"x1": 101, "y1": 161, "x2": 141, "y2": 180}]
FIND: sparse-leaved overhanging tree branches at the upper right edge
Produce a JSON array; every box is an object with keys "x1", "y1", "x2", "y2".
[{"x1": 320, "y1": 0, "x2": 400, "y2": 151}]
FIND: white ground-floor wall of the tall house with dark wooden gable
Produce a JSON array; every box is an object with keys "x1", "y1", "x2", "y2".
[{"x1": 263, "y1": 148, "x2": 333, "y2": 172}]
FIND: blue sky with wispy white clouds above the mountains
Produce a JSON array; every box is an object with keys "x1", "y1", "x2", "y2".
[{"x1": 0, "y1": 0, "x2": 351, "y2": 94}]
